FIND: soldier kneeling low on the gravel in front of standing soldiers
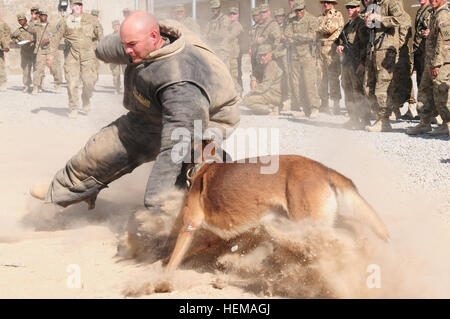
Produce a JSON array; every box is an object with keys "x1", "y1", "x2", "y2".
[{"x1": 242, "y1": 44, "x2": 283, "y2": 115}]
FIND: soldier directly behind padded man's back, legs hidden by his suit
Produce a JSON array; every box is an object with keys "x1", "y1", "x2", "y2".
[{"x1": 206, "y1": 0, "x2": 230, "y2": 69}]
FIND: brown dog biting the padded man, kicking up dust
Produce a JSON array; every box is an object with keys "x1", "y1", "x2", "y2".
[{"x1": 167, "y1": 155, "x2": 389, "y2": 271}]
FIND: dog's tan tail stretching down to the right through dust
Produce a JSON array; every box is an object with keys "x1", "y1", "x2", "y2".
[{"x1": 328, "y1": 169, "x2": 389, "y2": 241}]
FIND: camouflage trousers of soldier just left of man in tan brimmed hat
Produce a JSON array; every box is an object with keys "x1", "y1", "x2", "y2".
[{"x1": 290, "y1": 57, "x2": 320, "y2": 114}]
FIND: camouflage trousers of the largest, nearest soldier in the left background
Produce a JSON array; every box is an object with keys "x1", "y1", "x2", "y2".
[{"x1": 64, "y1": 54, "x2": 97, "y2": 109}]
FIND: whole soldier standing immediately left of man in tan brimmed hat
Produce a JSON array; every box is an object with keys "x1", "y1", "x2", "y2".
[{"x1": 284, "y1": 0, "x2": 320, "y2": 119}]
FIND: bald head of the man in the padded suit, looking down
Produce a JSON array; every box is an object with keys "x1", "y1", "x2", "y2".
[{"x1": 120, "y1": 11, "x2": 164, "y2": 63}]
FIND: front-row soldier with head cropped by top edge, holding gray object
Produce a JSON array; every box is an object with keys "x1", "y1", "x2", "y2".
[{"x1": 364, "y1": 0, "x2": 405, "y2": 132}]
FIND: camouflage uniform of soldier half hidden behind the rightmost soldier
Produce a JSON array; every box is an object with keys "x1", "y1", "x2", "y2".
[{"x1": 413, "y1": 5, "x2": 433, "y2": 86}]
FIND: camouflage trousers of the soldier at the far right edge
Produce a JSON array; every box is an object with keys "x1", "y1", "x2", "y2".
[{"x1": 417, "y1": 63, "x2": 450, "y2": 123}]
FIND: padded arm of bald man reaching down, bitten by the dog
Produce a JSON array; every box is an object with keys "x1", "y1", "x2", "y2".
[{"x1": 144, "y1": 82, "x2": 209, "y2": 213}]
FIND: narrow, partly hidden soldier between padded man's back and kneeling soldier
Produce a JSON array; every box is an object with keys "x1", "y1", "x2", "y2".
[{"x1": 228, "y1": 7, "x2": 244, "y2": 95}]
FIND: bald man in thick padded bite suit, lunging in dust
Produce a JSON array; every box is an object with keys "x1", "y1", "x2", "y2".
[{"x1": 32, "y1": 11, "x2": 239, "y2": 228}]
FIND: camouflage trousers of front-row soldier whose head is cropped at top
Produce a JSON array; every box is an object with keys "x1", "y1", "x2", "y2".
[{"x1": 364, "y1": 50, "x2": 397, "y2": 119}]
